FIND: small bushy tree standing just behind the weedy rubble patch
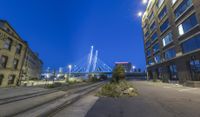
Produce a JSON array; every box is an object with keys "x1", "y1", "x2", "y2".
[{"x1": 112, "y1": 65, "x2": 125, "y2": 83}]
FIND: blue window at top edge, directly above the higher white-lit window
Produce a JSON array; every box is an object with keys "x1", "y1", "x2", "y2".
[{"x1": 174, "y1": 0, "x2": 192, "y2": 18}]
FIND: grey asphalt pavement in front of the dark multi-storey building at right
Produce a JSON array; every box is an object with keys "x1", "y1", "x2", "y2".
[{"x1": 86, "y1": 81, "x2": 200, "y2": 117}]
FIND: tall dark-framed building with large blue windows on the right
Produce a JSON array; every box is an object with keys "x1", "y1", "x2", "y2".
[{"x1": 142, "y1": 0, "x2": 200, "y2": 84}]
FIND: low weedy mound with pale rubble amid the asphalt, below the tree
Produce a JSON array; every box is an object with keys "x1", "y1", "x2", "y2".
[{"x1": 97, "y1": 80, "x2": 138, "y2": 97}]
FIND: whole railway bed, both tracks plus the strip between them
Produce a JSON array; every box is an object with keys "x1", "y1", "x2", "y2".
[{"x1": 0, "y1": 82, "x2": 105, "y2": 117}]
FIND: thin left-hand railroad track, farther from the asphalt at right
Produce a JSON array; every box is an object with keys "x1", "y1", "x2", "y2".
[{"x1": 0, "y1": 84, "x2": 92, "y2": 105}]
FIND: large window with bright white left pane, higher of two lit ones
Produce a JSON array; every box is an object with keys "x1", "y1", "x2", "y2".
[{"x1": 178, "y1": 14, "x2": 198, "y2": 36}]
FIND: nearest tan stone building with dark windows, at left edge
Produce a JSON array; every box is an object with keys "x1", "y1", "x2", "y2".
[{"x1": 0, "y1": 20, "x2": 27, "y2": 87}]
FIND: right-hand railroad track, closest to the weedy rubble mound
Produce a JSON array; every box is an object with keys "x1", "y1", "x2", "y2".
[{"x1": 14, "y1": 82, "x2": 105, "y2": 117}]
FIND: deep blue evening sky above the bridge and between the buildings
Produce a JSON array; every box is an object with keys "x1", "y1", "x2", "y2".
[{"x1": 0, "y1": 0, "x2": 145, "y2": 69}]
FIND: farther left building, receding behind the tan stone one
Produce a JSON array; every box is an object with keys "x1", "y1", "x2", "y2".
[{"x1": 22, "y1": 48, "x2": 43, "y2": 80}]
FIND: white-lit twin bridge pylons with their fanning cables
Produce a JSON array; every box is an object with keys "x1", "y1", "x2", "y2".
[{"x1": 72, "y1": 46, "x2": 112, "y2": 73}]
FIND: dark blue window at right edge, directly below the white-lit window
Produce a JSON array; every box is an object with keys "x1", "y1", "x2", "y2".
[{"x1": 181, "y1": 34, "x2": 200, "y2": 53}]
